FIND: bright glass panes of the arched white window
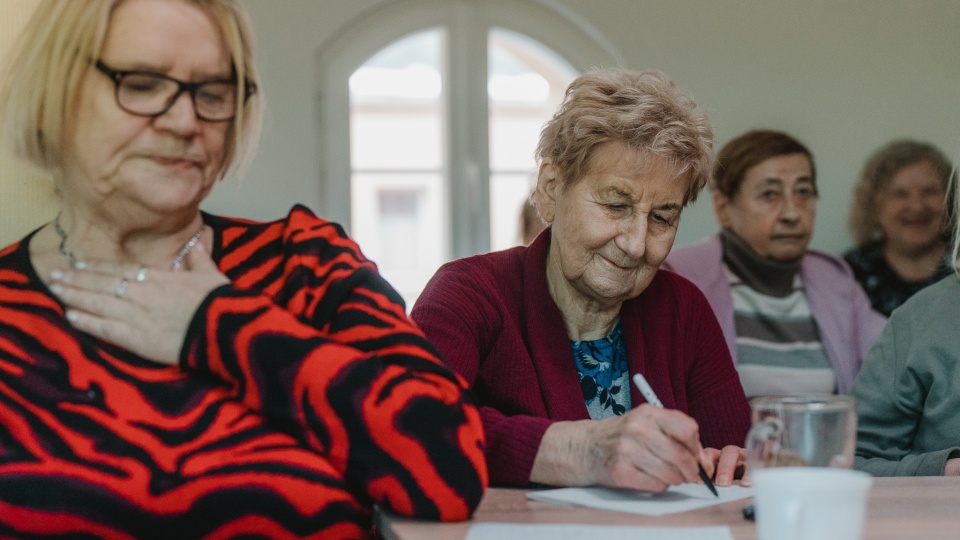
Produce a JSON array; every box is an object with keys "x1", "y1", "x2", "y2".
[{"x1": 350, "y1": 28, "x2": 576, "y2": 308}]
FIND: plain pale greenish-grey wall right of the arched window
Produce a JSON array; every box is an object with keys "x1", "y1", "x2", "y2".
[{"x1": 563, "y1": 0, "x2": 960, "y2": 252}]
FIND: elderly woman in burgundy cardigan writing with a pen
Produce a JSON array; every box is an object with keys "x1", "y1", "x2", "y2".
[{"x1": 411, "y1": 71, "x2": 749, "y2": 491}]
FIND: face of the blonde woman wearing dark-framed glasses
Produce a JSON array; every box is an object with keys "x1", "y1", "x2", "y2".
[{"x1": 63, "y1": 0, "x2": 233, "y2": 214}]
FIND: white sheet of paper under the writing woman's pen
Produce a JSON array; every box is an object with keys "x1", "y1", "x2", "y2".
[{"x1": 527, "y1": 484, "x2": 753, "y2": 516}]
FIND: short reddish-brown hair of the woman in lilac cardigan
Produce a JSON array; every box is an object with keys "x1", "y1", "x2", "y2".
[{"x1": 711, "y1": 129, "x2": 817, "y2": 199}]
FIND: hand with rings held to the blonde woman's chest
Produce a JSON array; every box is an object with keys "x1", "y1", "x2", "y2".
[{"x1": 50, "y1": 242, "x2": 230, "y2": 365}]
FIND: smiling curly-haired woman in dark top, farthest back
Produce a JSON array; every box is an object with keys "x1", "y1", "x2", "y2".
[{"x1": 843, "y1": 140, "x2": 953, "y2": 316}]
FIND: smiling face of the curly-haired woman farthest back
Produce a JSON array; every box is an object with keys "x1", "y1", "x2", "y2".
[{"x1": 877, "y1": 161, "x2": 945, "y2": 253}]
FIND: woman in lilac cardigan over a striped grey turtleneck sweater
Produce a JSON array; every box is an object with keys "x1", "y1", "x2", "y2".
[{"x1": 664, "y1": 130, "x2": 884, "y2": 397}]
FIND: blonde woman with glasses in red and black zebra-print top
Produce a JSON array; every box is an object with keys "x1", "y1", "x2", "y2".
[{"x1": 0, "y1": 0, "x2": 486, "y2": 538}]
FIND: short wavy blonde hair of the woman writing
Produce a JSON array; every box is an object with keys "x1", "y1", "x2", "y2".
[{"x1": 537, "y1": 69, "x2": 714, "y2": 204}]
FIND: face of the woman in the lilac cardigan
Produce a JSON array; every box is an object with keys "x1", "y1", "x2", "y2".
[{"x1": 713, "y1": 154, "x2": 816, "y2": 261}]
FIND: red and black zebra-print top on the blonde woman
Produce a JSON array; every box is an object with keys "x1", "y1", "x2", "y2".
[{"x1": 0, "y1": 206, "x2": 487, "y2": 538}]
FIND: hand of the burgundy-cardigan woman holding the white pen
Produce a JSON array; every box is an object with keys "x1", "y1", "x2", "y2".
[{"x1": 530, "y1": 404, "x2": 714, "y2": 492}]
